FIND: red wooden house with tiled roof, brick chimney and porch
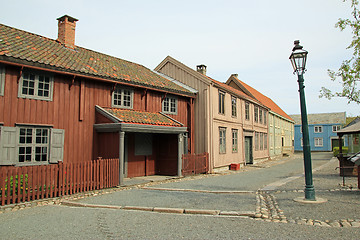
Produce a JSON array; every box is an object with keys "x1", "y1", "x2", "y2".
[{"x1": 0, "y1": 15, "x2": 196, "y2": 185}]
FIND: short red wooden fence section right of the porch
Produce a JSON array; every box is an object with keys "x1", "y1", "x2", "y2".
[{"x1": 182, "y1": 152, "x2": 209, "y2": 176}]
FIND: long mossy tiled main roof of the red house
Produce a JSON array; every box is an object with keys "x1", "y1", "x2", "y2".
[{"x1": 0, "y1": 24, "x2": 193, "y2": 95}]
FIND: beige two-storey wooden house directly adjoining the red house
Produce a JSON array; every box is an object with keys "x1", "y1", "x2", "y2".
[{"x1": 155, "y1": 56, "x2": 269, "y2": 172}]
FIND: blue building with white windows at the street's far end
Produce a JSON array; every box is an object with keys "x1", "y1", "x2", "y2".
[{"x1": 290, "y1": 112, "x2": 347, "y2": 151}]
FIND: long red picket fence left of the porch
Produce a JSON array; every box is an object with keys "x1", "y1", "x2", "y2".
[{"x1": 0, "y1": 159, "x2": 119, "y2": 206}]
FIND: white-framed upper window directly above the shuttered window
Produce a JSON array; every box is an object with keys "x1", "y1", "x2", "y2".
[{"x1": 18, "y1": 70, "x2": 54, "y2": 101}]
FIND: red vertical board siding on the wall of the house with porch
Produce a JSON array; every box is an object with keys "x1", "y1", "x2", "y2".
[{"x1": 0, "y1": 65, "x2": 189, "y2": 163}]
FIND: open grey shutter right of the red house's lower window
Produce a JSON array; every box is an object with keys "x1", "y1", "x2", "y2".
[{"x1": 49, "y1": 129, "x2": 65, "y2": 163}]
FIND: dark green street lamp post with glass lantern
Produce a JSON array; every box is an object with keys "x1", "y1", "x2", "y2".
[{"x1": 289, "y1": 40, "x2": 316, "y2": 201}]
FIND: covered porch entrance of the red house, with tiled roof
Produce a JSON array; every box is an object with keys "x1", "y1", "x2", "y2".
[{"x1": 94, "y1": 106, "x2": 187, "y2": 185}]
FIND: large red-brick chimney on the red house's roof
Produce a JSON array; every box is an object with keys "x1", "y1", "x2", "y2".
[{"x1": 56, "y1": 15, "x2": 79, "y2": 49}]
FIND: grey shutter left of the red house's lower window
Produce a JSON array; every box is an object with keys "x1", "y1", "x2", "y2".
[{"x1": 0, "y1": 127, "x2": 17, "y2": 165}]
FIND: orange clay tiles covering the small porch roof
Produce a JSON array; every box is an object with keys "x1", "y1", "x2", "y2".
[{"x1": 103, "y1": 108, "x2": 182, "y2": 127}]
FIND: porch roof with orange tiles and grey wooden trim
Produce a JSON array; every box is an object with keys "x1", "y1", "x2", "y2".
[{"x1": 94, "y1": 106, "x2": 187, "y2": 134}]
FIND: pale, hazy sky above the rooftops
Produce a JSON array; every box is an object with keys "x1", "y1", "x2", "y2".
[{"x1": 0, "y1": 0, "x2": 360, "y2": 116}]
